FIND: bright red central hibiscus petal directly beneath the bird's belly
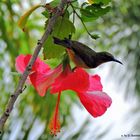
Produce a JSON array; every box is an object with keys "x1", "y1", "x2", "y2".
[{"x1": 51, "y1": 68, "x2": 89, "y2": 93}]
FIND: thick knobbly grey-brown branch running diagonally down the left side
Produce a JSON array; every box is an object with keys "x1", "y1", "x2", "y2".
[{"x1": 0, "y1": 0, "x2": 69, "y2": 133}]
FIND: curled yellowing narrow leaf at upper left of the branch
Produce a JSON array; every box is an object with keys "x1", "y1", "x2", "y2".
[{"x1": 18, "y1": 4, "x2": 42, "y2": 31}]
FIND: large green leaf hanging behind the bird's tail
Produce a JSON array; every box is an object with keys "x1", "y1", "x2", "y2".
[{"x1": 43, "y1": 17, "x2": 75, "y2": 59}]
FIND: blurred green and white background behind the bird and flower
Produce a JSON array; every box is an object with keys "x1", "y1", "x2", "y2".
[{"x1": 0, "y1": 0, "x2": 140, "y2": 140}]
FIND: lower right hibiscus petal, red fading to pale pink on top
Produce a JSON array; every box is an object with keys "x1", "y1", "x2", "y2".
[{"x1": 78, "y1": 91, "x2": 112, "y2": 117}]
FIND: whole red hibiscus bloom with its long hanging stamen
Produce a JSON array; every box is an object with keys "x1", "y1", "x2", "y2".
[{"x1": 16, "y1": 55, "x2": 112, "y2": 135}]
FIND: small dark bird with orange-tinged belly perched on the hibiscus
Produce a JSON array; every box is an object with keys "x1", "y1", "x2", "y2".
[{"x1": 53, "y1": 37, "x2": 122, "y2": 69}]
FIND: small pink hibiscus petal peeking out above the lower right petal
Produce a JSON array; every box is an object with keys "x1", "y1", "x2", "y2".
[{"x1": 88, "y1": 75, "x2": 103, "y2": 91}]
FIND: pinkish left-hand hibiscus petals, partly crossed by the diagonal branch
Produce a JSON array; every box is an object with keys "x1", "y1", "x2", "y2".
[{"x1": 15, "y1": 55, "x2": 62, "y2": 96}]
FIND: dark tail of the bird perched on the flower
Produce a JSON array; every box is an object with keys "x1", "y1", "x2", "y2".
[{"x1": 53, "y1": 37, "x2": 72, "y2": 48}]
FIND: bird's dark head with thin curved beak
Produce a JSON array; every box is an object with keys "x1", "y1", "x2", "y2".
[{"x1": 97, "y1": 52, "x2": 122, "y2": 65}]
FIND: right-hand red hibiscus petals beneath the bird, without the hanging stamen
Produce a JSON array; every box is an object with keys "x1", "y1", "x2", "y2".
[{"x1": 51, "y1": 66, "x2": 112, "y2": 117}]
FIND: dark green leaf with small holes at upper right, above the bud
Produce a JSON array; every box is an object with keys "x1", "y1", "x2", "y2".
[{"x1": 80, "y1": 4, "x2": 110, "y2": 22}]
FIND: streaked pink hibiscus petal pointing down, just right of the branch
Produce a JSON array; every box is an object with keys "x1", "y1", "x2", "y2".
[{"x1": 30, "y1": 65, "x2": 63, "y2": 96}]
